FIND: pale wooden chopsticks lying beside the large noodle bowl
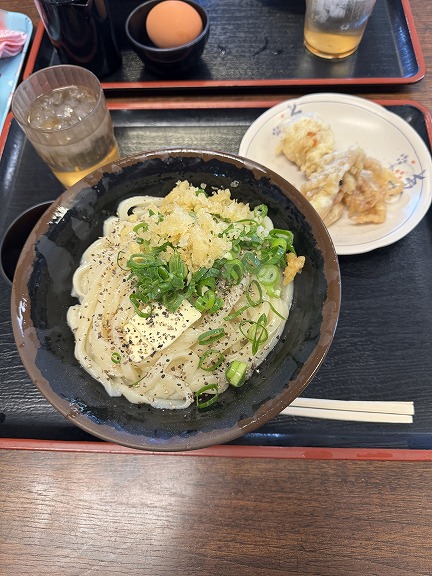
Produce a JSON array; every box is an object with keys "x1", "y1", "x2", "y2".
[{"x1": 281, "y1": 398, "x2": 414, "y2": 424}]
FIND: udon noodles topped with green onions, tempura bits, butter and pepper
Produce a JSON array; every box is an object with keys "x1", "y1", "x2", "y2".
[{"x1": 68, "y1": 182, "x2": 304, "y2": 409}]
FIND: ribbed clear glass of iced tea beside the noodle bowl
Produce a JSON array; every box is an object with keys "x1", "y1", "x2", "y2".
[{"x1": 12, "y1": 65, "x2": 119, "y2": 188}]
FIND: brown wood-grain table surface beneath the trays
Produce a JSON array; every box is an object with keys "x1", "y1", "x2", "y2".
[{"x1": 0, "y1": 0, "x2": 432, "y2": 576}]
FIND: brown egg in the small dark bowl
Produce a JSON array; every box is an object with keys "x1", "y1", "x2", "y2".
[{"x1": 146, "y1": 0, "x2": 203, "y2": 48}]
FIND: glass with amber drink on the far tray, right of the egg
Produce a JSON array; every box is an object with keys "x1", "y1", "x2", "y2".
[{"x1": 304, "y1": 0, "x2": 375, "y2": 60}]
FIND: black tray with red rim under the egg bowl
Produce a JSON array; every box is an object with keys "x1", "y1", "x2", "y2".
[{"x1": 24, "y1": 0, "x2": 425, "y2": 90}]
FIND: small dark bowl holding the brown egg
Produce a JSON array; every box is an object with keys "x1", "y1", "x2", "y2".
[{"x1": 125, "y1": 0, "x2": 210, "y2": 76}]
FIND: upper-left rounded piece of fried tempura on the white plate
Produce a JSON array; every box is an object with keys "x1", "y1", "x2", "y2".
[{"x1": 277, "y1": 116, "x2": 335, "y2": 177}]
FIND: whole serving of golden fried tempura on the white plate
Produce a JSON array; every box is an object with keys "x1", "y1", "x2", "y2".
[{"x1": 279, "y1": 112, "x2": 404, "y2": 226}]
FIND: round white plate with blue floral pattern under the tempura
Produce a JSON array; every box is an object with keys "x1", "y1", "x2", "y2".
[{"x1": 239, "y1": 93, "x2": 432, "y2": 255}]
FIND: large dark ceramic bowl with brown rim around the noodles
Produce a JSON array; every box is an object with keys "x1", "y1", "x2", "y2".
[{"x1": 12, "y1": 149, "x2": 341, "y2": 451}]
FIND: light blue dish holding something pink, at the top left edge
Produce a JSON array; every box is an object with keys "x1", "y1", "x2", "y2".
[{"x1": 0, "y1": 10, "x2": 33, "y2": 138}]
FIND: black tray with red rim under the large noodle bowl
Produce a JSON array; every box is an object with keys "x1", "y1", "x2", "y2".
[{"x1": 0, "y1": 102, "x2": 432, "y2": 449}]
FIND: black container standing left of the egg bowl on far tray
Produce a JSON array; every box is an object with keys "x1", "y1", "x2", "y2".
[{"x1": 34, "y1": 0, "x2": 121, "y2": 78}]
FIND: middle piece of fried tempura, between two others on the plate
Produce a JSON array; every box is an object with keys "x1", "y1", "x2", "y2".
[{"x1": 300, "y1": 146, "x2": 365, "y2": 226}]
